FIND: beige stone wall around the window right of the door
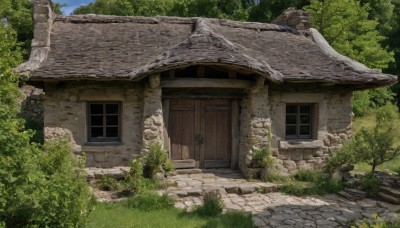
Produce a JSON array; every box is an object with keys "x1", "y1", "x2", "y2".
[{"x1": 269, "y1": 85, "x2": 352, "y2": 174}]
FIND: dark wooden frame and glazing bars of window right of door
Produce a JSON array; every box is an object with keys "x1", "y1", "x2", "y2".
[{"x1": 285, "y1": 103, "x2": 315, "y2": 139}]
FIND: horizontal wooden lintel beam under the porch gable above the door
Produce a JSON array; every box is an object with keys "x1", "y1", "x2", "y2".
[{"x1": 161, "y1": 78, "x2": 254, "y2": 89}]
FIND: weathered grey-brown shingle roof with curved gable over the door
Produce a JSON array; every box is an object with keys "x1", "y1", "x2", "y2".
[{"x1": 19, "y1": 3, "x2": 397, "y2": 87}]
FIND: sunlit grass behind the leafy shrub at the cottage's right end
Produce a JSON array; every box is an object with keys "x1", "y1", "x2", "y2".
[{"x1": 353, "y1": 112, "x2": 400, "y2": 173}]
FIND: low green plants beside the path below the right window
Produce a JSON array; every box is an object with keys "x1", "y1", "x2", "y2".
[{"x1": 280, "y1": 169, "x2": 345, "y2": 196}]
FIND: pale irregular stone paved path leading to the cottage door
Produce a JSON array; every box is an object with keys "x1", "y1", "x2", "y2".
[{"x1": 160, "y1": 170, "x2": 400, "y2": 227}]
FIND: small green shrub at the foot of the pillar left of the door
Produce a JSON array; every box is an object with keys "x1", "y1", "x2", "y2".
[{"x1": 143, "y1": 143, "x2": 168, "y2": 178}]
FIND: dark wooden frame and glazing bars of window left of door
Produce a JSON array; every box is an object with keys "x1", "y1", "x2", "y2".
[{"x1": 86, "y1": 101, "x2": 122, "y2": 142}]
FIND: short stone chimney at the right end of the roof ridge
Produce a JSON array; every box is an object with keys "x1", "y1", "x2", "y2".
[{"x1": 272, "y1": 8, "x2": 311, "y2": 31}]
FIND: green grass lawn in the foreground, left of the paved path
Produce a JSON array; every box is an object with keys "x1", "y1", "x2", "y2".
[{"x1": 87, "y1": 203, "x2": 253, "y2": 228}]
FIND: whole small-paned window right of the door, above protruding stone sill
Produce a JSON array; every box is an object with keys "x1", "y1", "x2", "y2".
[{"x1": 286, "y1": 104, "x2": 313, "y2": 139}]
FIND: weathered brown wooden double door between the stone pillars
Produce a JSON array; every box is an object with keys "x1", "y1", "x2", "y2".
[{"x1": 168, "y1": 99, "x2": 232, "y2": 168}]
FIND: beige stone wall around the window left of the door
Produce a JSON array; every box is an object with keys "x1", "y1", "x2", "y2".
[{"x1": 44, "y1": 82, "x2": 143, "y2": 168}]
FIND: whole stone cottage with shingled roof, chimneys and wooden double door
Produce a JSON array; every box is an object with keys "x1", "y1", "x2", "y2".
[{"x1": 19, "y1": 0, "x2": 396, "y2": 174}]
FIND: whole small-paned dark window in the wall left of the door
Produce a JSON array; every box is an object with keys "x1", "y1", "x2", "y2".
[{"x1": 88, "y1": 102, "x2": 121, "y2": 142}]
